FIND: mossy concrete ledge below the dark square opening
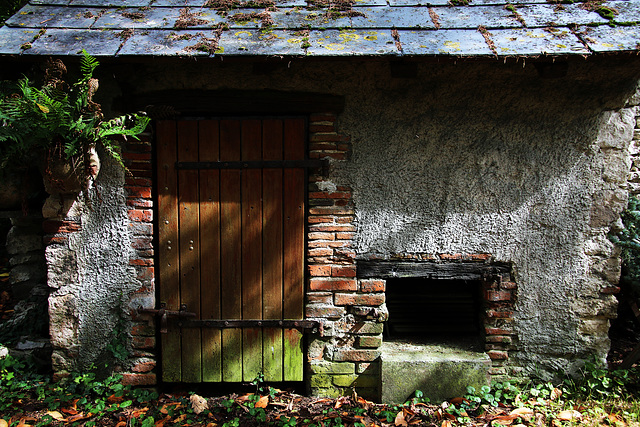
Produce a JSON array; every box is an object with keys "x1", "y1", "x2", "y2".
[{"x1": 380, "y1": 342, "x2": 491, "y2": 404}]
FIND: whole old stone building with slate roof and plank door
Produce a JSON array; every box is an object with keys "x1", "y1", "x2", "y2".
[{"x1": 0, "y1": 0, "x2": 640, "y2": 401}]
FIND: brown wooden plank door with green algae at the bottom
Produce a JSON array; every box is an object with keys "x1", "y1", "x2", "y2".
[{"x1": 156, "y1": 118, "x2": 306, "y2": 382}]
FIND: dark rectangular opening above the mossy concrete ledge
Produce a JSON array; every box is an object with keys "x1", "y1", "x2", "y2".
[{"x1": 385, "y1": 277, "x2": 484, "y2": 351}]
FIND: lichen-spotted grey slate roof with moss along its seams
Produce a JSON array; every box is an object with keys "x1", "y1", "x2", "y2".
[{"x1": 0, "y1": 0, "x2": 640, "y2": 57}]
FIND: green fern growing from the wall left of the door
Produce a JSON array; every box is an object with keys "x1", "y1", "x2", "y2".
[{"x1": 0, "y1": 50, "x2": 149, "y2": 184}]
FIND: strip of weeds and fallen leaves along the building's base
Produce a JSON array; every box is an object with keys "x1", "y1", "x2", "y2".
[{"x1": 0, "y1": 356, "x2": 640, "y2": 427}]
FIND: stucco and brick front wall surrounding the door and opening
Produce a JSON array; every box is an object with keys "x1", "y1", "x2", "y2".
[{"x1": 40, "y1": 58, "x2": 639, "y2": 397}]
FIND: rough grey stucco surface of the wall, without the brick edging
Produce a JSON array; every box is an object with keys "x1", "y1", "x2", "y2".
[{"x1": 77, "y1": 54, "x2": 638, "y2": 382}]
